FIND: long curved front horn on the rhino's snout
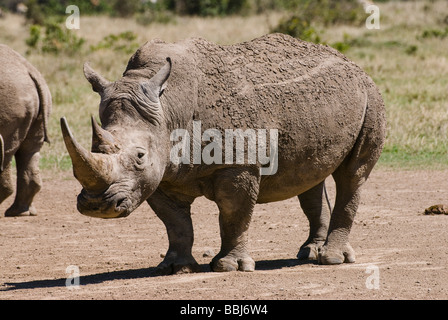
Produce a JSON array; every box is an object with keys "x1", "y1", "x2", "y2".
[{"x1": 61, "y1": 117, "x2": 113, "y2": 193}]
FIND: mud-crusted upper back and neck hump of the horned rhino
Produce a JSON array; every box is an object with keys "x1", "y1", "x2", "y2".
[{"x1": 124, "y1": 34, "x2": 368, "y2": 129}]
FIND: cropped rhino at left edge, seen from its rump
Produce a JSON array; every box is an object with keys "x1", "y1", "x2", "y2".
[{"x1": 0, "y1": 44, "x2": 51, "y2": 217}]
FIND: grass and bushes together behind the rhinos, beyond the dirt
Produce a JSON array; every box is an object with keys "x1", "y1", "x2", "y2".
[{"x1": 0, "y1": 0, "x2": 448, "y2": 170}]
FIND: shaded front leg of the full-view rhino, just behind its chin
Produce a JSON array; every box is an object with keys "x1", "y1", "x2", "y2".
[{"x1": 147, "y1": 189, "x2": 199, "y2": 275}]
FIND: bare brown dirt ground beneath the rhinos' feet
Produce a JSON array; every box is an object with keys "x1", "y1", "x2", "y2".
[{"x1": 0, "y1": 169, "x2": 448, "y2": 300}]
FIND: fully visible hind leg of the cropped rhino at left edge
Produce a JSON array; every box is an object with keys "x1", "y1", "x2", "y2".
[{"x1": 5, "y1": 146, "x2": 42, "y2": 217}]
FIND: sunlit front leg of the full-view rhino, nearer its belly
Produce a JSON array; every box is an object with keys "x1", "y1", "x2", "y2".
[{"x1": 211, "y1": 169, "x2": 259, "y2": 271}]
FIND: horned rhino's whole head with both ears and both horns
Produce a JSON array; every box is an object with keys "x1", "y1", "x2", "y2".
[{"x1": 61, "y1": 58, "x2": 171, "y2": 218}]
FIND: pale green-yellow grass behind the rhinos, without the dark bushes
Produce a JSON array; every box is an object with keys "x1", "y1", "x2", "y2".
[{"x1": 0, "y1": 0, "x2": 448, "y2": 170}]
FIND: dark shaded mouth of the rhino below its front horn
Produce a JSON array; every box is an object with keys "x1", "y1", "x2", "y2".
[{"x1": 77, "y1": 189, "x2": 132, "y2": 219}]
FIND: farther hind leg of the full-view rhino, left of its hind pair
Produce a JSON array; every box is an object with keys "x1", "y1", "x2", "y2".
[{"x1": 297, "y1": 181, "x2": 330, "y2": 260}]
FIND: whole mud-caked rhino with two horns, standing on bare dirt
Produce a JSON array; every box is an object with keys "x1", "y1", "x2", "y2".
[{"x1": 61, "y1": 34, "x2": 386, "y2": 274}]
